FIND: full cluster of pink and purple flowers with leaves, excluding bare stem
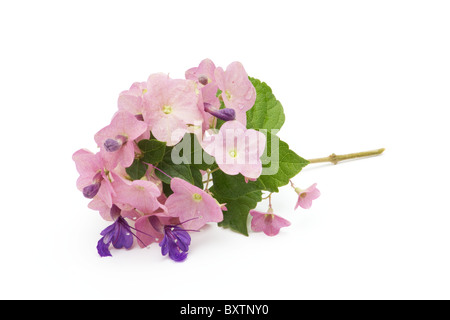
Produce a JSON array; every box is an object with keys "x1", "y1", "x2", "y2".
[{"x1": 73, "y1": 59, "x2": 319, "y2": 261}]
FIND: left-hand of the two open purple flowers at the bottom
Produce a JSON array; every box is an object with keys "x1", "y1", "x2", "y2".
[{"x1": 97, "y1": 205, "x2": 133, "y2": 257}]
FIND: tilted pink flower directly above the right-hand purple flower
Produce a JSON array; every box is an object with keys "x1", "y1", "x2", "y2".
[{"x1": 165, "y1": 178, "x2": 223, "y2": 230}]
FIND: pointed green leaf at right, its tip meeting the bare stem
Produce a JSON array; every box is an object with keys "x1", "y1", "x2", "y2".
[{"x1": 258, "y1": 132, "x2": 309, "y2": 192}]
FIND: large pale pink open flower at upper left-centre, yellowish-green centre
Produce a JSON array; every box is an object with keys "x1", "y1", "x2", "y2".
[{"x1": 143, "y1": 74, "x2": 203, "y2": 146}]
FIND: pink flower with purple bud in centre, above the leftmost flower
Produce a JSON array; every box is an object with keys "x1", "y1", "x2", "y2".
[{"x1": 94, "y1": 111, "x2": 148, "y2": 168}]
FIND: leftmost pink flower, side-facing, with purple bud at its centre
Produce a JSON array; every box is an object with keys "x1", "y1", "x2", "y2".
[{"x1": 72, "y1": 149, "x2": 115, "y2": 207}]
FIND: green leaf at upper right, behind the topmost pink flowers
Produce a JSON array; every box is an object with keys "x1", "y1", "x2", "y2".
[{"x1": 247, "y1": 77, "x2": 285, "y2": 130}]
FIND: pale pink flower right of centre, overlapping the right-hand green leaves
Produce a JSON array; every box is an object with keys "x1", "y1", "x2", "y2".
[{"x1": 202, "y1": 121, "x2": 266, "y2": 180}]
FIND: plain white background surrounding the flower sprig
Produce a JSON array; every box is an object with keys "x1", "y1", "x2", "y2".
[{"x1": 0, "y1": 0, "x2": 450, "y2": 299}]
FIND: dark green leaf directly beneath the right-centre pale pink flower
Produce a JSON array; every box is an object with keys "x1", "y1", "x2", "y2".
[{"x1": 212, "y1": 170, "x2": 264, "y2": 199}]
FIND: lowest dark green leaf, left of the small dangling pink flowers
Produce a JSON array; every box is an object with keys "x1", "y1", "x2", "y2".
[{"x1": 210, "y1": 186, "x2": 262, "y2": 236}]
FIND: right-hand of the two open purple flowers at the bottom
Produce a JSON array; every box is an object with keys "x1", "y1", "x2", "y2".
[{"x1": 159, "y1": 223, "x2": 191, "y2": 262}]
